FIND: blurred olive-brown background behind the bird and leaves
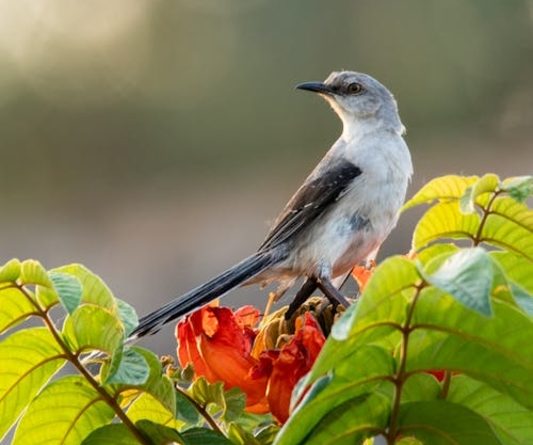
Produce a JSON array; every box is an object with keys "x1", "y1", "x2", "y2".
[{"x1": 0, "y1": 0, "x2": 533, "y2": 353}]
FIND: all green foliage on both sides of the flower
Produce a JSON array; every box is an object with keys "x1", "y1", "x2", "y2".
[{"x1": 0, "y1": 175, "x2": 533, "y2": 445}]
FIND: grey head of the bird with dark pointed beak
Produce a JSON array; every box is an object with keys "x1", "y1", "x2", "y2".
[{"x1": 296, "y1": 71, "x2": 403, "y2": 132}]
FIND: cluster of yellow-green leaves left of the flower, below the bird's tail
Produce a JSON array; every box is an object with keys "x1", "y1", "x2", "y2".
[{"x1": 0, "y1": 260, "x2": 277, "y2": 445}]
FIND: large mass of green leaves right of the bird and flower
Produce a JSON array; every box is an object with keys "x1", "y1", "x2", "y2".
[{"x1": 275, "y1": 175, "x2": 533, "y2": 445}]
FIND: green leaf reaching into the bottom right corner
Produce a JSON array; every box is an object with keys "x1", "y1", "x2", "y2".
[{"x1": 447, "y1": 375, "x2": 533, "y2": 445}]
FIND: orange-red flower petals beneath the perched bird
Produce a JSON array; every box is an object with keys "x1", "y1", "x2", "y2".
[{"x1": 176, "y1": 306, "x2": 325, "y2": 422}]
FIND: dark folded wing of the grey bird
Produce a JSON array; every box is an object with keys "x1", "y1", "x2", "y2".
[{"x1": 259, "y1": 160, "x2": 361, "y2": 250}]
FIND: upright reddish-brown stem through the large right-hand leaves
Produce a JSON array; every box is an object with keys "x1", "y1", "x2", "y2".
[{"x1": 385, "y1": 281, "x2": 426, "y2": 445}]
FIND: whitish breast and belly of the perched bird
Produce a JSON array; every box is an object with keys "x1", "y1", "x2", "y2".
[{"x1": 291, "y1": 131, "x2": 412, "y2": 277}]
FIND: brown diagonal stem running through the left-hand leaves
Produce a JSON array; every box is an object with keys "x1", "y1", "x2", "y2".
[{"x1": 17, "y1": 284, "x2": 150, "y2": 445}]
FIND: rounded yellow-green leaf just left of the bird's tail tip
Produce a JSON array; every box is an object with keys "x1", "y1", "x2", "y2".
[{"x1": 63, "y1": 303, "x2": 124, "y2": 356}]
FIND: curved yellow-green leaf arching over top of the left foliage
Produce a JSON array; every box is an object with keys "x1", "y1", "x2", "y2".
[{"x1": 53, "y1": 264, "x2": 117, "y2": 312}]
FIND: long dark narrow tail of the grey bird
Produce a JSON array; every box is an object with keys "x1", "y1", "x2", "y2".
[{"x1": 128, "y1": 252, "x2": 278, "y2": 341}]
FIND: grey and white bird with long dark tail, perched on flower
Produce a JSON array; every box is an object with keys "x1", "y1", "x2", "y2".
[{"x1": 130, "y1": 71, "x2": 413, "y2": 340}]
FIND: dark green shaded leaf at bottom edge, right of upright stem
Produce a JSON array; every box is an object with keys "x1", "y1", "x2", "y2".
[{"x1": 399, "y1": 400, "x2": 501, "y2": 445}]
